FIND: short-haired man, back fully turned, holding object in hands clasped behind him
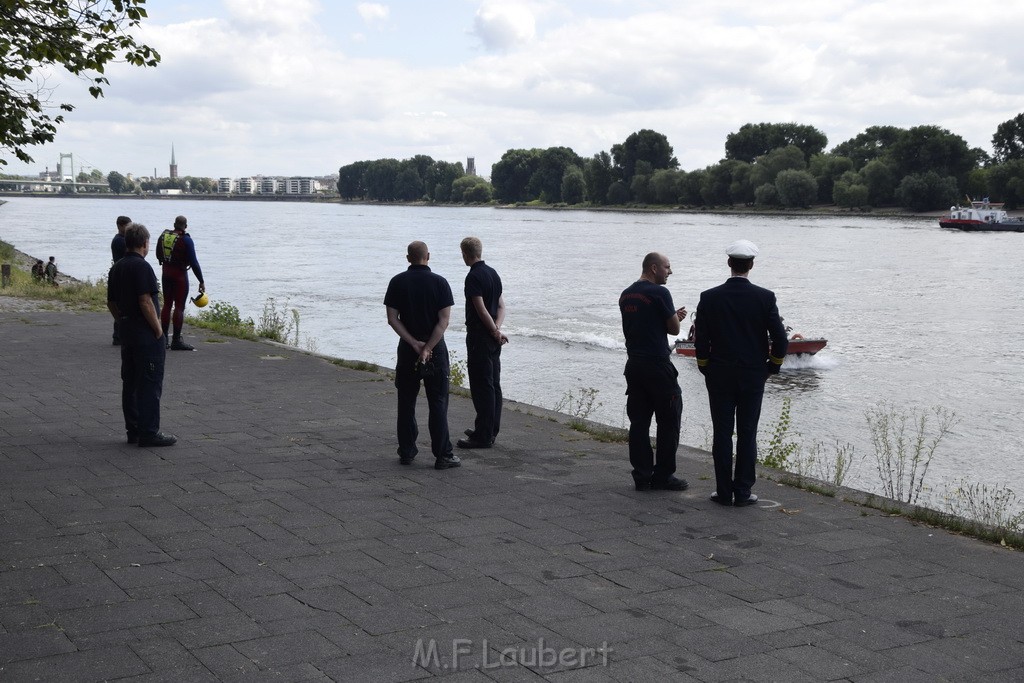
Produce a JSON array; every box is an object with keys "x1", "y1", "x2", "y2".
[{"x1": 384, "y1": 242, "x2": 462, "y2": 470}]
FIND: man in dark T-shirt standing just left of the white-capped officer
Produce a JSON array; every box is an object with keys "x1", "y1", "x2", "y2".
[{"x1": 618, "y1": 252, "x2": 689, "y2": 490}]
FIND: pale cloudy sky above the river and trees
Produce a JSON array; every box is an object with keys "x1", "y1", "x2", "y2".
[{"x1": 0, "y1": 0, "x2": 1024, "y2": 178}]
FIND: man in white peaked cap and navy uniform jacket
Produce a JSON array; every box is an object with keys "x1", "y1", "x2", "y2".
[{"x1": 694, "y1": 240, "x2": 788, "y2": 507}]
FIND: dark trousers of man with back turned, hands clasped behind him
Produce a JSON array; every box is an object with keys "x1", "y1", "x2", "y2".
[{"x1": 394, "y1": 341, "x2": 452, "y2": 458}]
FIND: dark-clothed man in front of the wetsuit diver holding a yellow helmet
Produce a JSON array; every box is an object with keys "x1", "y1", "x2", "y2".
[{"x1": 106, "y1": 223, "x2": 177, "y2": 446}]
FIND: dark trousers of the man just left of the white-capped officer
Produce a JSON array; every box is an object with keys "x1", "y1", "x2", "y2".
[{"x1": 624, "y1": 357, "x2": 683, "y2": 483}]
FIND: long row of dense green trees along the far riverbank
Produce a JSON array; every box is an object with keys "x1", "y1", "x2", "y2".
[{"x1": 338, "y1": 114, "x2": 1024, "y2": 211}]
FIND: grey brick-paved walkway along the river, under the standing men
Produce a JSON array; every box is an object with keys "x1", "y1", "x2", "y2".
[{"x1": 0, "y1": 311, "x2": 1024, "y2": 682}]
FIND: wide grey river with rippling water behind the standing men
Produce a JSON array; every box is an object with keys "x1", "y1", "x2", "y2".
[{"x1": 0, "y1": 197, "x2": 1024, "y2": 509}]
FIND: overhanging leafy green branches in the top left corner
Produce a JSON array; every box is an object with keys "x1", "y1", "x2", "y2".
[{"x1": 0, "y1": 0, "x2": 160, "y2": 166}]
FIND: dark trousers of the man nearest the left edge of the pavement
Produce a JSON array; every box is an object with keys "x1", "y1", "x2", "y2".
[{"x1": 118, "y1": 317, "x2": 167, "y2": 437}]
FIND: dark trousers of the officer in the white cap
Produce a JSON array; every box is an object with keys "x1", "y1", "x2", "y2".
[{"x1": 705, "y1": 362, "x2": 768, "y2": 500}]
